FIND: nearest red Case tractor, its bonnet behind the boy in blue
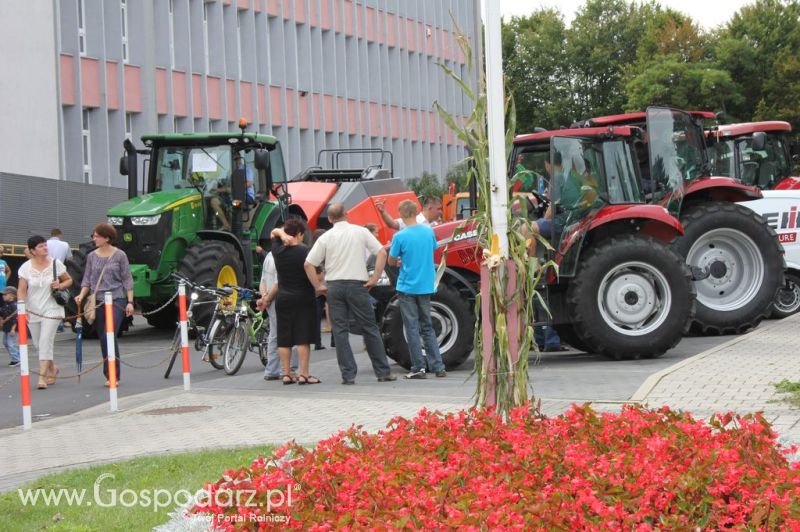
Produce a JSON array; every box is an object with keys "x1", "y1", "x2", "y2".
[{"x1": 382, "y1": 126, "x2": 695, "y2": 368}]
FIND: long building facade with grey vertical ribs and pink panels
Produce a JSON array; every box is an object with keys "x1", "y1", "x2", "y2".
[{"x1": 0, "y1": 0, "x2": 479, "y2": 188}]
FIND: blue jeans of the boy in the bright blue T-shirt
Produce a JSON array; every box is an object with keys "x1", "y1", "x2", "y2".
[{"x1": 397, "y1": 293, "x2": 444, "y2": 373}]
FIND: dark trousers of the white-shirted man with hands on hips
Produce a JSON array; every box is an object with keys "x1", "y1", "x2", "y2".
[{"x1": 325, "y1": 281, "x2": 392, "y2": 380}]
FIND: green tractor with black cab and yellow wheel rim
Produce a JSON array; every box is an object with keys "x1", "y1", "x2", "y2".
[{"x1": 68, "y1": 124, "x2": 306, "y2": 329}]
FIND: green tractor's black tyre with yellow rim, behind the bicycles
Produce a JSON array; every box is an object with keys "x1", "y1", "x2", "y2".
[{"x1": 178, "y1": 240, "x2": 245, "y2": 327}]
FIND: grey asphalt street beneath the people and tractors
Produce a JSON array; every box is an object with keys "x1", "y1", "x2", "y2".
[{"x1": 0, "y1": 318, "x2": 730, "y2": 428}]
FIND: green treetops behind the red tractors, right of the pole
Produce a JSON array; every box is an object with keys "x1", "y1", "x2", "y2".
[{"x1": 503, "y1": 0, "x2": 800, "y2": 133}]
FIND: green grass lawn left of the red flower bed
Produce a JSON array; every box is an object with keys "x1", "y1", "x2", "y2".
[{"x1": 0, "y1": 445, "x2": 273, "y2": 532}]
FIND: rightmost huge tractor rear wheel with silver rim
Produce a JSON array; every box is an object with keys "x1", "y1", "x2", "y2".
[{"x1": 672, "y1": 202, "x2": 783, "y2": 335}]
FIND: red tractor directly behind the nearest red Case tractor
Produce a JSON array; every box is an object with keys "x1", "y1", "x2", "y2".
[{"x1": 585, "y1": 107, "x2": 785, "y2": 334}]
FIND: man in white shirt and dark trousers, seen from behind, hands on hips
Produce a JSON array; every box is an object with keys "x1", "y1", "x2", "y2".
[{"x1": 304, "y1": 203, "x2": 397, "y2": 384}]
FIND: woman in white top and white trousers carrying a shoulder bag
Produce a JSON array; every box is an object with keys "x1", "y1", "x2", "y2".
[{"x1": 17, "y1": 235, "x2": 72, "y2": 390}]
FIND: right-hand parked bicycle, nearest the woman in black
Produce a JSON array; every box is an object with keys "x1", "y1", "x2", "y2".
[{"x1": 222, "y1": 286, "x2": 269, "y2": 375}]
